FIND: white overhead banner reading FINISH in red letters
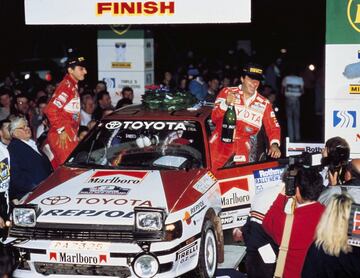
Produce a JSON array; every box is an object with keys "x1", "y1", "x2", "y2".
[{"x1": 25, "y1": 0, "x2": 251, "y2": 25}]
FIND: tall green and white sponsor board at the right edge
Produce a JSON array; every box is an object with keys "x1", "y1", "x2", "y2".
[{"x1": 325, "y1": 0, "x2": 360, "y2": 157}]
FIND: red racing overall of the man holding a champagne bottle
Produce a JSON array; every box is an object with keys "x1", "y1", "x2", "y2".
[{"x1": 210, "y1": 86, "x2": 280, "y2": 168}]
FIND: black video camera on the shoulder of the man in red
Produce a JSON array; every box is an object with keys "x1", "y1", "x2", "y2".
[{"x1": 279, "y1": 152, "x2": 323, "y2": 196}]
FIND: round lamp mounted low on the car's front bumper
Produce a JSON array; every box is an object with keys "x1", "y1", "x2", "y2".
[{"x1": 133, "y1": 254, "x2": 159, "y2": 278}]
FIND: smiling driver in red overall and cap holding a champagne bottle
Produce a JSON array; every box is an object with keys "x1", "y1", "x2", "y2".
[{"x1": 210, "y1": 63, "x2": 281, "y2": 168}]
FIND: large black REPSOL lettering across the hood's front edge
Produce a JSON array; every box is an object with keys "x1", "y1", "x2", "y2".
[{"x1": 42, "y1": 209, "x2": 134, "y2": 218}]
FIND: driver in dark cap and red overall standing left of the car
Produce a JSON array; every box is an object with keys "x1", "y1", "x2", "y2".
[{"x1": 44, "y1": 57, "x2": 87, "y2": 169}]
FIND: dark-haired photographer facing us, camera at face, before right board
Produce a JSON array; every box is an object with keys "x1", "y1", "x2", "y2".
[{"x1": 322, "y1": 136, "x2": 350, "y2": 185}]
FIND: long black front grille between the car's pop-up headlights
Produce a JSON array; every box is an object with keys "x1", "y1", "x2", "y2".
[{"x1": 10, "y1": 224, "x2": 162, "y2": 242}]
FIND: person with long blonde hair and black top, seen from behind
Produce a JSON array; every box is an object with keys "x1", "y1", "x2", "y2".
[{"x1": 302, "y1": 193, "x2": 360, "y2": 278}]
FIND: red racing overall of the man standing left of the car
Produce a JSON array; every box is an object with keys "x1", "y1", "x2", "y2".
[{"x1": 44, "y1": 74, "x2": 80, "y2": 169}]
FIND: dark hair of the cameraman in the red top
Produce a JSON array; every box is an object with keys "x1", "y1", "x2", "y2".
[{"x1": 295, "y1": 167, "x2": 323, "y2": 201}]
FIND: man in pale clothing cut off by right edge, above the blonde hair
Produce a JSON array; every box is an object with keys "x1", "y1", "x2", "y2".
[{"x1": 318, "y1": 158, "x2": 360, "y2": 205}]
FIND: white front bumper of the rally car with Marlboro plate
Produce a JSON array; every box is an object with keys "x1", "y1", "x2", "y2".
[{"x1": 13, "y1": 236, "x2": 200, "y2": 278}]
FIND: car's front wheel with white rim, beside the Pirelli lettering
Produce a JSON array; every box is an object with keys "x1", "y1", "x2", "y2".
[{"x1": 194, "y1": 220, "x2": 218, "y2": 278}]
